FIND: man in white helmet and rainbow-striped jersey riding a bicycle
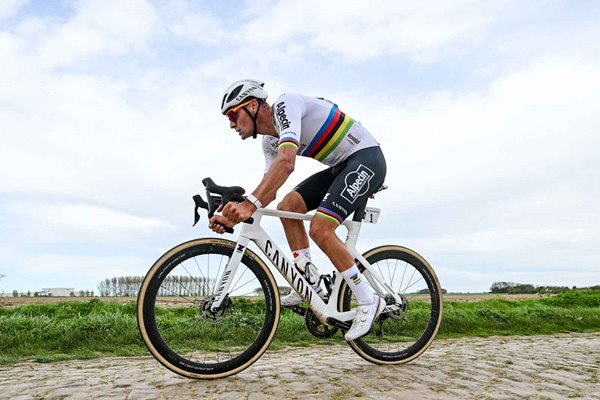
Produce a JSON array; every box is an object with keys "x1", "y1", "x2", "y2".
[{"x1": 209, "y1": 79, "x2": 386, "y2": 340}]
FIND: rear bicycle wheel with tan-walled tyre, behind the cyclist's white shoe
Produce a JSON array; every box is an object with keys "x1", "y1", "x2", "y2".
[{"x1": 338, "y1": 246, "x2": 442, "y2": 364}]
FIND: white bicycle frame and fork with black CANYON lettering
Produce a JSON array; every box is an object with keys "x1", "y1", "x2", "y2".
[{"x1": 211, "y1": 208, "x2": 403, "y2": 324}]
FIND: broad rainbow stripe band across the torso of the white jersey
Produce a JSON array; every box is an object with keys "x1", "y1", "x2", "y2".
[{"x1": 302, "y1": 104, "x2": 355, "y2": 161}]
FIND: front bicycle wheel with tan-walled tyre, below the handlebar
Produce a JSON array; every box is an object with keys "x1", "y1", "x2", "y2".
[{"x1": 137, "y1": 238, "x2": 280, "y2": 379}]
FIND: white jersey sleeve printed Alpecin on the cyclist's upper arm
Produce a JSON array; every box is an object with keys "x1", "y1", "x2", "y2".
[{"x1": 273, "y1": 94, "x2": 306, "y2": 150}]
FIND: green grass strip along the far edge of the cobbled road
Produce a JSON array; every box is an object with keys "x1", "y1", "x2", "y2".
[{"x1": 0, "y1": 291, "x2": 600, "y2": 364}]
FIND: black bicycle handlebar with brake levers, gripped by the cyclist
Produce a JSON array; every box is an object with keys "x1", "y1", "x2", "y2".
[{"x1": 192, "y1": 178, "x2": 254, "y2": 233}]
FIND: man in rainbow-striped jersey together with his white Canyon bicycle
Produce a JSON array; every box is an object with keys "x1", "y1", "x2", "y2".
[{"x1": 138, "y1": 80, "x2": 442, "y2": 379}]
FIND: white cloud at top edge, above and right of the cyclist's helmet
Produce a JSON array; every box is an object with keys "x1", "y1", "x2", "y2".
[{"x1": 234, "y1": 0, "x2": 502, "y2": 60}]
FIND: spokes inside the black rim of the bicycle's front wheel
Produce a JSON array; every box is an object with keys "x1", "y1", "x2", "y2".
[{"x1": 141, "y1": 242, "x2": 273, "y2": 376}]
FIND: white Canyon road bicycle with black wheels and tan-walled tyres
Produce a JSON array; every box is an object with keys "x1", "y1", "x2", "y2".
[{"x1": 137, "y1": 178, "x2": 442, "y2": 379}]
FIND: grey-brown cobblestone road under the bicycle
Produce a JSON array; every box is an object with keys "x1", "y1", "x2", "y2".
[{"x1": 0, "y1": 333, "x2": 600, "y2": 400}]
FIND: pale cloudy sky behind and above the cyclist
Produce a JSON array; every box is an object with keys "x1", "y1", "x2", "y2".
[{"x1": 0, "y1": 0, "x2": 600, "y2": 293}]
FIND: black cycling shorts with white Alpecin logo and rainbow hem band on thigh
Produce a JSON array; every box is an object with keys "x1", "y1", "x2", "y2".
[{"x1": 295, "y1": 146, "x2": 387, "y2": 224}]
